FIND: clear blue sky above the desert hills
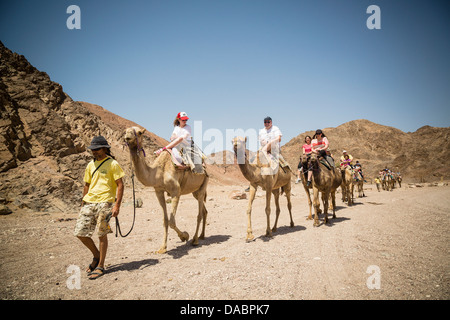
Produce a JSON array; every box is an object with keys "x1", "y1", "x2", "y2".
[{"x1": 0, "y1": 0, "x2": 450, "y2": 151}]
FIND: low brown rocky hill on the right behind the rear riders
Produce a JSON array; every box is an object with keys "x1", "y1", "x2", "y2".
[{"x1": 282, "y1": 120, "x2": 450, "y2": 182}]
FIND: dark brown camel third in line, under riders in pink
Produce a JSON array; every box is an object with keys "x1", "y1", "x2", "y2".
[{"x1": 311, "y1": 153, "x2": 342, "y2": 227}]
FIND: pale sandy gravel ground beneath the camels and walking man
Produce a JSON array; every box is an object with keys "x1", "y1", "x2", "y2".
[{"x1": 0, "y1": 184, "x2": 450, "y2": 300}]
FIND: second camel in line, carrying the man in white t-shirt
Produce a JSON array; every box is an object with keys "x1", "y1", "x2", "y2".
[{"x1": 232, "y1": 137, "x2": 294, "y2": 241}]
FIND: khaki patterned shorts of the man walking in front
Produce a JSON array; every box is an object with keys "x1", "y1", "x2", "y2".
[{"x1": 73, "y1": 202, "x2": 113, "y2": 238}]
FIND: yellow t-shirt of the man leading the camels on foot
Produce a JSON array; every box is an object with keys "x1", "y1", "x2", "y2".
[{"x1": 83, "y1": 158, "x2": 125, "y2": 203}]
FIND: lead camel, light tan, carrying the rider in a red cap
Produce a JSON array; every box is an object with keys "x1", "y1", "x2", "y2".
[{"x1": 125, "y1": 127, "x2": 209, "y2": 254}]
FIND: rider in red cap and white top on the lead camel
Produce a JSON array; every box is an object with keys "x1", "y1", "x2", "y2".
[{"x1": 155, "y1": 112, "x2": 192, "y2": 163}]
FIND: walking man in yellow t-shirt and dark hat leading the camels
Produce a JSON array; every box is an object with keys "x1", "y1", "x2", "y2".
[{"x1": 74, "y1": 136, "x2": 125, "y2": 280}]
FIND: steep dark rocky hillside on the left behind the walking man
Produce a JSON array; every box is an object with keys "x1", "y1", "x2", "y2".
[{"x1": 0, "y1": 42, "x2": 165, "y2": 211}]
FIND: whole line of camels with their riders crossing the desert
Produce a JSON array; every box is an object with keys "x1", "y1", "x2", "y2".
[{"x1": 120, "y1": 112, "x2": 401, "y2": 253}]
